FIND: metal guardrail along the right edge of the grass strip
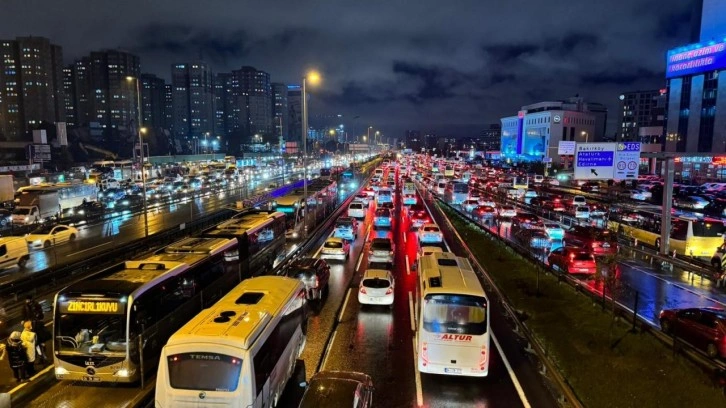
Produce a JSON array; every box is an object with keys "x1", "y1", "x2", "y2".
[{"x1": 436, "y1": 191, "x2": 726, "y2": 392}]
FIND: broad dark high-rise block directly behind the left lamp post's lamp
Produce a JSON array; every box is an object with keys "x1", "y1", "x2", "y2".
[{"x1": 65, "y1": 50, "x2": 141, "y2": 130}]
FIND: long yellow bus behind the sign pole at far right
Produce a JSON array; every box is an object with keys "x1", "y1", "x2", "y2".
[{"x1": 608, "y1": 205, "x2": 726, "y2": 258}]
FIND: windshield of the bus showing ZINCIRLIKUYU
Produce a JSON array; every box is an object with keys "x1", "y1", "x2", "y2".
[{"x1": 54, "y1": 311, "x2": 127, "y2": 355}]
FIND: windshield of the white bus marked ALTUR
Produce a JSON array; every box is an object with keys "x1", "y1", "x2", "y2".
[{"x1": 422, "y1": 294, "x2": 487, "y2": 336}]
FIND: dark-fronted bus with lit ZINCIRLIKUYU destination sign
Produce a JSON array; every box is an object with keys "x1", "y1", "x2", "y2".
[{"x1": 53, "y1": 238, "x2": 241, "y2": 383}]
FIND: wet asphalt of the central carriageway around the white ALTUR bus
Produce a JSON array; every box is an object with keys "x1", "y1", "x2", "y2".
[{"x1": 18, "y1": 163, "x2": 557, "y2": 408}]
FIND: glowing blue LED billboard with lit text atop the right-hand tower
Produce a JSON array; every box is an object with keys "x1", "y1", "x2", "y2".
[{"x1": 666, "y1": 39, "x2": 726, "y2": 78}]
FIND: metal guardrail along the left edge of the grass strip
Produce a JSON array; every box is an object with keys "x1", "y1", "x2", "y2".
[{"x1": 419, "y1": 186, "x2": 583, "y2": 408}]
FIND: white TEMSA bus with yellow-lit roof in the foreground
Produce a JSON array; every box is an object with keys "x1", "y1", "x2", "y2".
[{"x1": 154, "y1": 276, "x2": 307, "y2": 408}]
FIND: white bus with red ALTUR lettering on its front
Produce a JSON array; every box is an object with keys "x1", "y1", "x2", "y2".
[{"x1": 416, "y1": 252, "x2": 491, "y2": 377}]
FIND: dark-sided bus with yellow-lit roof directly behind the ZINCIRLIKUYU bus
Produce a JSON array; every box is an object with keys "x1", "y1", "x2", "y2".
[{"x1": 202, "y1": 210, "x2": 285, "y2": 278}]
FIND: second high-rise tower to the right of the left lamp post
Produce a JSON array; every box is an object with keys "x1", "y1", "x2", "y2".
[{"x1": 171, "y1": 62, "x2": 216, "y2": 143}]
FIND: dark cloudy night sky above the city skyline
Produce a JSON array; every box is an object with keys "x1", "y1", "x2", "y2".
[{"x1": 0, "y1": 0, "x2": 704, "y2": 137}]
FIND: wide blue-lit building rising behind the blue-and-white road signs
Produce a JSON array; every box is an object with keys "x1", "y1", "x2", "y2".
[{"x1": 500, "y1": 97, "x2": 607, "y2": 162}]
